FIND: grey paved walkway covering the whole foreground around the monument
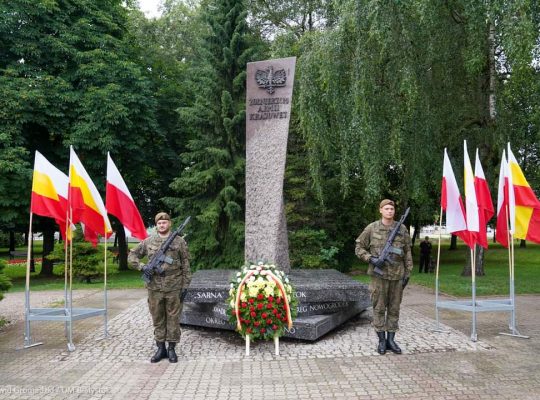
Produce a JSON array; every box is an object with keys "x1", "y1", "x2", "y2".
[{"x1": 0, "y1": 286, "x2": 540, "y2": 400}]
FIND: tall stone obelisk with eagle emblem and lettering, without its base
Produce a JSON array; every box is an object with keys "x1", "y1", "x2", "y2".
[{"x1": 245, "y1": 57, "x2": 296, "y2": 272}]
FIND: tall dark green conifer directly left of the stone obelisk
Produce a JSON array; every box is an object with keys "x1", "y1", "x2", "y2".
[{"x1": 167, "y1": 0, "x2": 264, "y2": 268}]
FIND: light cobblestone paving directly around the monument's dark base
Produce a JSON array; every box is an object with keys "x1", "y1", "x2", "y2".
[{"x1": 57, "y1": 292, "x2": 491, "y2": 362}]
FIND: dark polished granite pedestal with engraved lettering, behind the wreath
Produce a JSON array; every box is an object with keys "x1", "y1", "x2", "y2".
[{"x1": 180, "y1": 270, "x2": 371, "y2": 340}]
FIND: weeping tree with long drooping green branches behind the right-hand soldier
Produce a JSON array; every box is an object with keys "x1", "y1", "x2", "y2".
[{"x1": 298, "y1": 0, "x2": 539, "y2": 268}]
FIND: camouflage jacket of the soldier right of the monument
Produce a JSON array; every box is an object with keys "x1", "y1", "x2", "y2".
[{"x1": 355, "y1": 220, "x2": 413, "y2": 280}]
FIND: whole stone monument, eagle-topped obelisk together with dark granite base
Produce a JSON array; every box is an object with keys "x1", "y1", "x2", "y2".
[{"x1": 180, "y1": 57, "x2": 370, "y2": 340}]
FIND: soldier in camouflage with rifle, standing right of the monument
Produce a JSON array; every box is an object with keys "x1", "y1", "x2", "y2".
[{"x1": 355, "y1": 199, "x2": 413, "y2": 354}]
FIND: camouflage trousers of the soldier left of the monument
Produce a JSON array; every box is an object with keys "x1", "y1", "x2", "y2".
[{"x1": 148, "y1": 290, "x2": 182, "y2": 342}]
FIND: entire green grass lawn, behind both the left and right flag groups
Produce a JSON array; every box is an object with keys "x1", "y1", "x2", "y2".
[{"x1": 0, "y1": 241, "x2": 540, "y2": 297}]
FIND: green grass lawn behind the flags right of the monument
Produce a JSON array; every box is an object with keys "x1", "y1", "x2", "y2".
[{"x1": 348, "y1": 242, "x2": 540, "y2": 297}]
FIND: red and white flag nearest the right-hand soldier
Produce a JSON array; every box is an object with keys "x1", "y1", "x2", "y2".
[{"x1": 441, "y1": 148, "x2": 472, "y2": 247}]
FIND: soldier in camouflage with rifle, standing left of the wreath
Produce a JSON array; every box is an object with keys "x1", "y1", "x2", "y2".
[{"x1": 128, "y1": 212, "x2": 191, "y2": 363}]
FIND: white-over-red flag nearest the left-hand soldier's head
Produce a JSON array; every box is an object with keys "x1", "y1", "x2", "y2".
[{"x1": 105, "y1": 153, "x2": 148, "y2": 240}]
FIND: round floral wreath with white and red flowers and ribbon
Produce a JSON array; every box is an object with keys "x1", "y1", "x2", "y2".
[{"x1": 227, "y1": 262, "x2": 297, "y2": 340}]
